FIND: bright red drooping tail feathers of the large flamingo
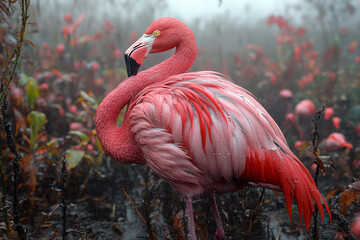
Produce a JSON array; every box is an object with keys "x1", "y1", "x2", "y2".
[{"x1": 241, "y1": 148, "x2": 331, "y2": 231}]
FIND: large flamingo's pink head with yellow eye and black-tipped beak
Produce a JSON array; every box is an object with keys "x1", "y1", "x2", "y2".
[{"x1": 124, "y1": 17, "x2": 194, "y2": 77}]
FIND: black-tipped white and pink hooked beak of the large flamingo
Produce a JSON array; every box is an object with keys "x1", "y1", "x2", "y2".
[{"x1": 124, "y1": 34, "x2": 154, "y2": 77}]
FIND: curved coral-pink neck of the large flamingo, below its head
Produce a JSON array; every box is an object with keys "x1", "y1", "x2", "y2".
[{"x1": 95, "y1": 38, "x2": 197, "y2": 163}]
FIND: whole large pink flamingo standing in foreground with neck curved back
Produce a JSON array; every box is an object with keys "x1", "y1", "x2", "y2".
[{"x1": 95, "y1": 17, "x2": 330, "y2": 239}]
